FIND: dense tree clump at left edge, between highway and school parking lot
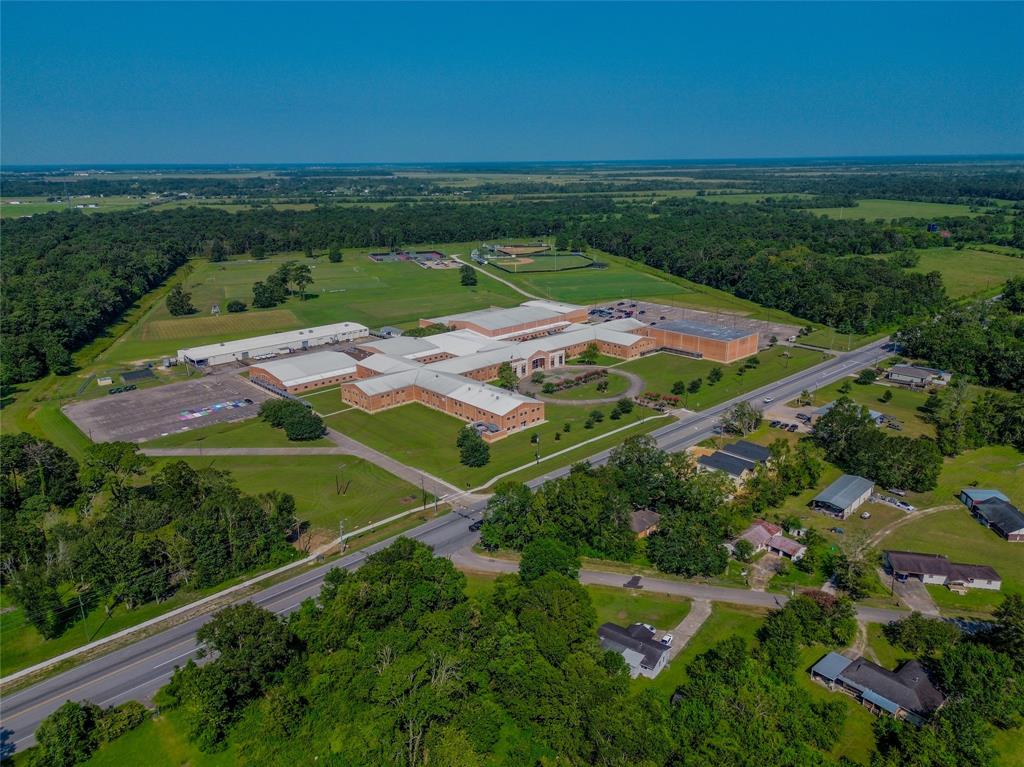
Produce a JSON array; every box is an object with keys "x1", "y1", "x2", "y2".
[{"x1": 0, "y1": 433, "x2": 296, "y2": 639}]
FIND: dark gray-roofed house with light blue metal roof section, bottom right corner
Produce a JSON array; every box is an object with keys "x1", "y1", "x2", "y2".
[{"x1": 811, "y1": 652, "x2": 945, "y2": 724}]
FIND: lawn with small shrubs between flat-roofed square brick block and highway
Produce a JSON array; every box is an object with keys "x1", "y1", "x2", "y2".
[{"x1": 618, "y1": 346, "x2": 826, "y2": 411}]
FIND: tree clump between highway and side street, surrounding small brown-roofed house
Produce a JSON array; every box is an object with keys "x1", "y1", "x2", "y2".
[{"x1": 480, "y1": 436, "x2": 821, "y2": 576}]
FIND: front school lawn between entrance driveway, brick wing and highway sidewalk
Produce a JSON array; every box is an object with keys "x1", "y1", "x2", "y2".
[{"x1": 326, "y1": 402, "x2": 650, "y2": 487}]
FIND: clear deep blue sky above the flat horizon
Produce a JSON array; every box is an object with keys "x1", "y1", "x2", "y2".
[{"x1": 0, "y1": 2, "x2": 1024, "y2": 165}]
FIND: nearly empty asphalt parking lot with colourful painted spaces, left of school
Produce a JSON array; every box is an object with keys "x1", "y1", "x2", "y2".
[{"x1": 63, "y1": 373, "x2": 272, "y2": 442}]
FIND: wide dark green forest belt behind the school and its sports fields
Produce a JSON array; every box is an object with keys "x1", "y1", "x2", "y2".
[{"x1": 8, "y1": 190, "x2": 1012, "y2": 384}]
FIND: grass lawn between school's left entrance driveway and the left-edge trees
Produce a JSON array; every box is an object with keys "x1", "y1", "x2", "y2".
[{"x1": 149, "y1": 456, "x2": 423, "y2": 536}]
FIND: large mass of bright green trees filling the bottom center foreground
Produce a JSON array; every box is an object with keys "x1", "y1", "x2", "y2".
[{"x1": 138, "y1": 539, "x2": 864, "y2": 767}]
